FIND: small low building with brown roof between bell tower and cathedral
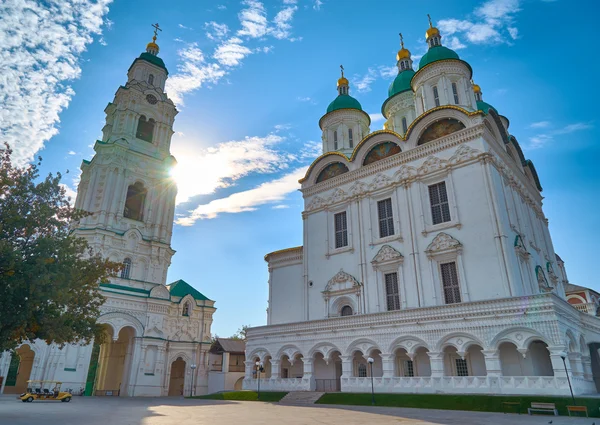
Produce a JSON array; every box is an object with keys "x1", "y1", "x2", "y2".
[{"x1": 208, "y1": 338, "x2": 246, "y2": 394}]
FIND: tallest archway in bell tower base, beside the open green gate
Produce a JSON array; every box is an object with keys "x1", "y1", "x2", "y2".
[{"x1": 94, "y1": 326, "x2": 135, "y2": 395}]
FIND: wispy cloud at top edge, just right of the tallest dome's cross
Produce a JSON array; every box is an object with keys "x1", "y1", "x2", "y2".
[{"x1": 437, "y1": 0, "x2": 520, "y2": 49}]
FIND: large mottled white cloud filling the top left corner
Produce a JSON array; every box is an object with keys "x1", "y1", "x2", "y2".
[{"x1": 0, "y1": 0, "x2": 111, "y2": 164}]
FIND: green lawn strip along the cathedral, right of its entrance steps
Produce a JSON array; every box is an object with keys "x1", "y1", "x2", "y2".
[{"x1": 317, "y1": 393, "x2": 600, "y2": 417}]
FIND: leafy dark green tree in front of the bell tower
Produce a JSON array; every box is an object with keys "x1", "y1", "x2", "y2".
[{"x1": 0, "y1": 145, "x2": 121, "y2": 353}]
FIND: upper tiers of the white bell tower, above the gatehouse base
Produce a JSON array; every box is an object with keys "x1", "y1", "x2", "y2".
[{"x1": 73, "y1": 24, "x2": 177, "y2": 290}]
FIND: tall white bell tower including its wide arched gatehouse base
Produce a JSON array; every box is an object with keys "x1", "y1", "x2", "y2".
[{"x1": 0, "y1": 31, "x2": 215, "y2": 396}]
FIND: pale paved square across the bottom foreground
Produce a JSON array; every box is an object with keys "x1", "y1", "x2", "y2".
[{"x1": 0, "y1": 396, "x2": 600, "y2": 425}]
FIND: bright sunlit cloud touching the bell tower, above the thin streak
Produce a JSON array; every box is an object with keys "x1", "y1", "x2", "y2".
[{"x1": 173, "y1": 134, "x2": 290, "y2": 203}]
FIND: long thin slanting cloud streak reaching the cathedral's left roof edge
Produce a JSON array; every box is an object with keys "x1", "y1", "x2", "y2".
[{"x1": 175, "y1": 167, "x2": 308, "y2": 226}]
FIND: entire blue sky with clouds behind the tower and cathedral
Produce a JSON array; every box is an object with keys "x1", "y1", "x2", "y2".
[{"x1": 0, "y1": 0, "x2": 600, "y2": 337}]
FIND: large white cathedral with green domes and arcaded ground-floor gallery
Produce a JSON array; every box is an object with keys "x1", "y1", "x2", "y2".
[{"x1": 244, "y1": 22, "x2": 600, "y2": 395}]
